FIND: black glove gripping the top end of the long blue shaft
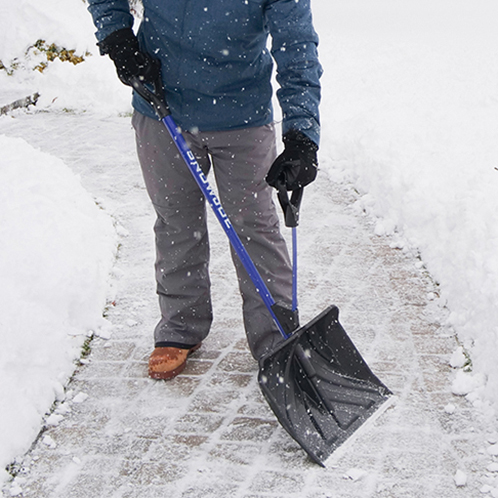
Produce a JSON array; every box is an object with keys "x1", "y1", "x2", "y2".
[{"x1": 98, "y1": 28, "x2": 161, "y2": 86}]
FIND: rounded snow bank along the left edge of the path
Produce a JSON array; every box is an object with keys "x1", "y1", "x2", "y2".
[{"x1": 0, "y1": 135, "x2": 116, "y2": 480}]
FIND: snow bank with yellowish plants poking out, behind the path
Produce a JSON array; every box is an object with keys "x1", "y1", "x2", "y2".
[{"x1": 0, "y1": 0, "x2": 131, "y2": 115}]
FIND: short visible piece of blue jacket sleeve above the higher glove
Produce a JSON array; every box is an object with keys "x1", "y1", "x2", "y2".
[{"x1": 88, "y1": 0, "x2": 133, "y2": 42}]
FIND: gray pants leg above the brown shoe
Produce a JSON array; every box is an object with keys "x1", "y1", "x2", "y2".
[{"x1": 132, "y1": 113, "x2": 212, "y2": 347}]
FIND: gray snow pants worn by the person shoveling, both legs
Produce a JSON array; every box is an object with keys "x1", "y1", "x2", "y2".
[{"x1": 132, "y1": 112, "x2": 292, "y2": 359}]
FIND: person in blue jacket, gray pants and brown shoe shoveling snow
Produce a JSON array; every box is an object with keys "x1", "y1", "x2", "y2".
[{"x1": 88, "y1": 0, "x2": 322, "y2": 379}]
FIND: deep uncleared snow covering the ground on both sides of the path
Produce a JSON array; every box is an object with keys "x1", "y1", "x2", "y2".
[{"x1": 0, "y1": 0, "x2": 498, "y2": 486}]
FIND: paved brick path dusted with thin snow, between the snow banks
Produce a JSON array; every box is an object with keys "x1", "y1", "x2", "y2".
[{"x1": 0, "y1": 113, "x2": 493, "y2": 498}]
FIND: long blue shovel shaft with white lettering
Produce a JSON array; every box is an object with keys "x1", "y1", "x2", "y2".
[{"x1": 162, "y1": 115, "x2": 290, "y2": 339}]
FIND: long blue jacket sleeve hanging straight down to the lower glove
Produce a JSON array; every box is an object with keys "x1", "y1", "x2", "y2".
[{"x1": 266, "y1": 0, "x2": 322, "y2": 145}]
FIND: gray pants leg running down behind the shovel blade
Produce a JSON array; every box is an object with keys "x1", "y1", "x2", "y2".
[{"x1": 202, "y1": 125, "x2": 292, "y2": 359}]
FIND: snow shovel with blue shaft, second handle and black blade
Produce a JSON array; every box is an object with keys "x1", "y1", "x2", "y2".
[{"x1": 132, "y1": 78, "x2": 392, "y2": 466}]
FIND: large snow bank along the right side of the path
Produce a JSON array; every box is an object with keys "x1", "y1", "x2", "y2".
[{"x1": 315, "y1": 0, "x2": 498, "y2": 408}]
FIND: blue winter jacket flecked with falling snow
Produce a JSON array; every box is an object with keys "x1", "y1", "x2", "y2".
[{"x1": 89, "y1": 0, "x2": 322, "y2": 144}]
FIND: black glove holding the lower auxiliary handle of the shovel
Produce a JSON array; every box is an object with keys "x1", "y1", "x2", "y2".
[{"x1": 266, "y1": 130, "x2": 318, "y2": 190}]
